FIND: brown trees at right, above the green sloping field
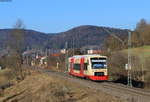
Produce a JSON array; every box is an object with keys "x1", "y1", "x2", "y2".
[{"x1": 105, "y1": 19, "x2": 150, "y2": 51}]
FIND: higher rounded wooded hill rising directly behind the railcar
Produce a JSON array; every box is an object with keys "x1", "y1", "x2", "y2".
[{"x1": 52, "y1": 25, "x2": 128, "y2": 48}]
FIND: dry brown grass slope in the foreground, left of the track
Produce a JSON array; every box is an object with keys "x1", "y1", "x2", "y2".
[{"x1": 1, "y1": 72, "x2": 126, "y2": 102}]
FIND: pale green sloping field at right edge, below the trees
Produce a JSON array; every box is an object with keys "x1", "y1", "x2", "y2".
[{"x1": 122, "y1": 46, "x2": 150, "y2": 58}]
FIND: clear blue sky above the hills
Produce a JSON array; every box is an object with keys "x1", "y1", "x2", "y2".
[{"x1": 0, "y1": 0, "x2": 150, "y2": 33}]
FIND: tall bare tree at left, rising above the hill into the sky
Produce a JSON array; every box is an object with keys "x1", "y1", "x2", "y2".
[{"x1": 8, "y1": 19, "x2": 24, "y2": 80}]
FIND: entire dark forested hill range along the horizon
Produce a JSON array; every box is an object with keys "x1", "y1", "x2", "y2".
[{"x1": 0, "y1": 25, "x2": 128, "y2": 48}]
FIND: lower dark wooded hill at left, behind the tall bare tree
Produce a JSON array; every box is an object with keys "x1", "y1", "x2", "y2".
[{"x1": 0, "y1": 29, "x2": 53, "y2": 48}]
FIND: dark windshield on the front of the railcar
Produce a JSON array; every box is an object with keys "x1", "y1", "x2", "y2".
[{"x1": 91, "y1": 58, "x2": 107, "y2": 69}]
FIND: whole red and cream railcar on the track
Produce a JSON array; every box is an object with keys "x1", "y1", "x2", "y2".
[{"x1": 68, "y1": 55, "x2": 108, "y2": 81}]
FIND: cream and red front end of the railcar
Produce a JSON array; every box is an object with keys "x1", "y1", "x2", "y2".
[{"x1": 89, "y1": 56, "x2": 108, "y2": 81}]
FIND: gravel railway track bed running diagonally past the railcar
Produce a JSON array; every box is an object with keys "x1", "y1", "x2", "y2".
[{"x1": 33, "y1": 67, "x2": 150, "y2": 102}]
